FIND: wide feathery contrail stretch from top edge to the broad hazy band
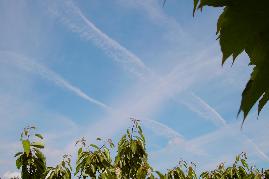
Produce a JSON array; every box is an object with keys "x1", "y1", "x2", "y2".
[{"x1": 50, "y1": 1, "x2": 152, "y2": 78}]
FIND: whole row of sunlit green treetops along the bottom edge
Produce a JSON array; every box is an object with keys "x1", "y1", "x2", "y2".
[{"x1": 15, "y1": 120, "x2": 269, "y2": 179}]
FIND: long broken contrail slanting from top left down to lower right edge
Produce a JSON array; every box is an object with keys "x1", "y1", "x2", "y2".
[{"x1": 48, "y1": 1, "x2": 269, "y2": 159}]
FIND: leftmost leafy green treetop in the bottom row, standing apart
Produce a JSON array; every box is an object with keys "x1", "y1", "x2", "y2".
[{"x1": 15, "y1": 126, "x2": 46, "y2": 179}]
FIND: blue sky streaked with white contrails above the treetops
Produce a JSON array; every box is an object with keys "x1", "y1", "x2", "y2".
[{"x1": 0, "y1": 0, "x2": 269, "y2": 178}]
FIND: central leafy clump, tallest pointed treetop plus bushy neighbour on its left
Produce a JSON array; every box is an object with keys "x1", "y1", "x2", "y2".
[{"x1": 75, "y1": 120, "x2": 155, "y2": 179}]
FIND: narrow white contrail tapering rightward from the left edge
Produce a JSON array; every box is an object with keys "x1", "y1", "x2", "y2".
[{"x1": 0, "y1": 51, "x2": 110, "y2": 110}]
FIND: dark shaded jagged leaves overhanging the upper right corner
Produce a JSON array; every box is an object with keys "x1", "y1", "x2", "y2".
[{"x1": 193, "y1": 0, "x2": 269, "y2": 122}]
